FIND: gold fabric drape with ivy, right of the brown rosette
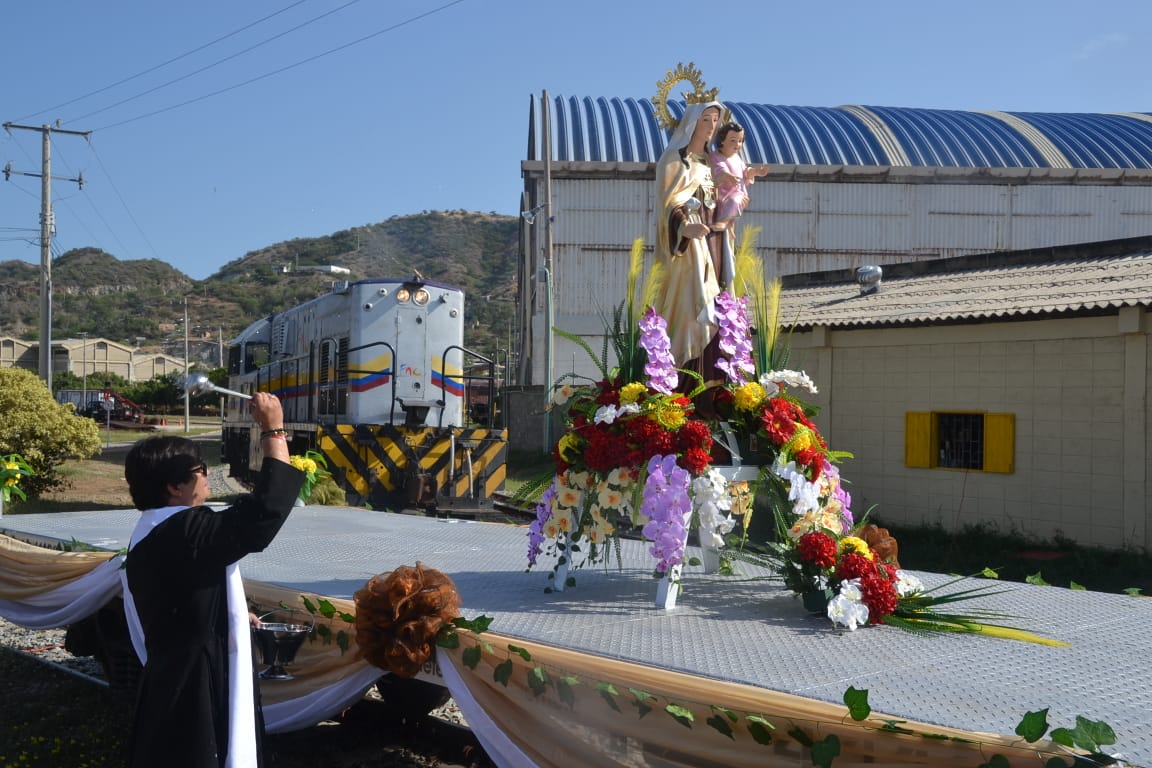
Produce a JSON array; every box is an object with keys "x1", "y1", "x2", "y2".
[{"x1": 440, "y1": 632, "x2": 1069, "y2": 768}]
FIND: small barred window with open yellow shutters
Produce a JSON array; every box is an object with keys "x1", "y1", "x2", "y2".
[{"x1": 904, "y1": 411, "x2": 1016, "y2": 473}]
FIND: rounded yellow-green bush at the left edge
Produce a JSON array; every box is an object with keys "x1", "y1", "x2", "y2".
[{"x1": 0, "y1": 367, "x2": 100, "y2": 499}]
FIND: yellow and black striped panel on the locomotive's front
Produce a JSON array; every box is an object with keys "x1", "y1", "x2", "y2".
[{"x1": 317, "y1": 424, "x2": 508, "y2": 507}]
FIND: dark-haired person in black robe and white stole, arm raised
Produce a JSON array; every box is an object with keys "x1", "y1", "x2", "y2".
[{"x1": 124, "y1": 393, "x2": 304, "y2": 768}]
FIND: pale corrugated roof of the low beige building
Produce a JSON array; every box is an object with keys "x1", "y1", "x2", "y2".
[{"x1": 781, "y1": 250, "x2": 1152, "y2": 328}]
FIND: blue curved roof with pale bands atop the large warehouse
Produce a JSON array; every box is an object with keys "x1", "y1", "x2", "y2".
[{"x1": 528, "y1": 96, "x2": 1152, "y2": 168}]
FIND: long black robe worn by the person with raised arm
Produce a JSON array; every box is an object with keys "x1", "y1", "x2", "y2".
[{"x1": 126, "y1": 459, "x2": 304, "y2": 768}]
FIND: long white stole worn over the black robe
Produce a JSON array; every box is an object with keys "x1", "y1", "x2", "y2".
[{"x1": 120, "y1": 507, "x2": 256, "y2": 768}]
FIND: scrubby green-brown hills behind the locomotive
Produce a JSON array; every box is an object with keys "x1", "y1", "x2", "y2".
[{"x1": 0, "y1": 211, "x2": 518, "y2": 366}]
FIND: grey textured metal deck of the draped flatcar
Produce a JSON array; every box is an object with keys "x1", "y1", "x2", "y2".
[{"x1": 0, "y1": 507, "x2": 1152, "y2": 766}]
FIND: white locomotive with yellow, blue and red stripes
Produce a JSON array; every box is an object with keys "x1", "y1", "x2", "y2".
[{"x1": 222, "y1": 276, "x2": 508, "y2": 516}]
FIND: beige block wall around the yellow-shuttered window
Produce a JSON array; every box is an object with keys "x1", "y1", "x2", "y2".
[{"x1": 789, "y1": 307, "x2": 1152, "y2": 547}]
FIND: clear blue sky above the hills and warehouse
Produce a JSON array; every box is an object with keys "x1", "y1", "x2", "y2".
[{"x1": 0, "y1": 0, "x2": 1152, "y2": 279}]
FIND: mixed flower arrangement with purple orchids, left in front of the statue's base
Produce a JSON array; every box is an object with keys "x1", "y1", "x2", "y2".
[{"x1": 528, "y1": 241, "x2": 734, "y2": 576}]
